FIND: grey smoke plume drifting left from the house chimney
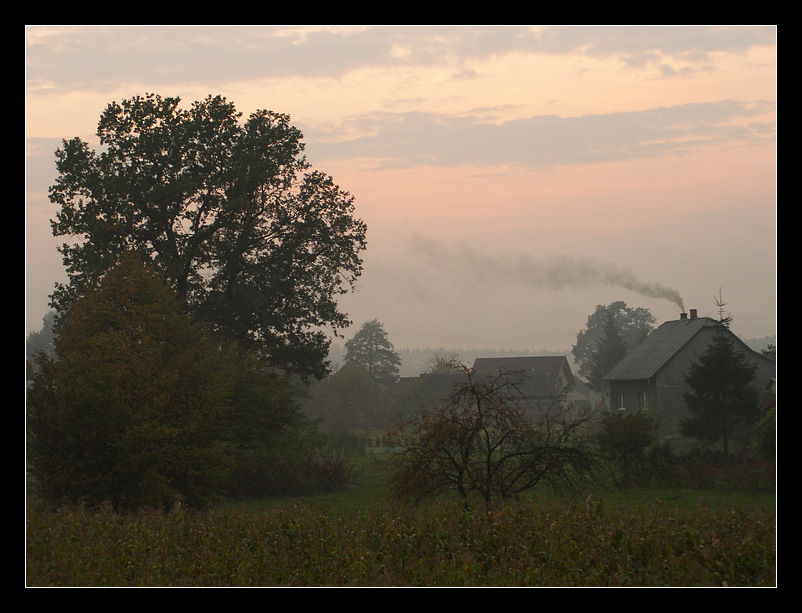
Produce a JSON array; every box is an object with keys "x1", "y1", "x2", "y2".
[{"x1": 413, "y1": 237, "x2": 685, "y2": 311}]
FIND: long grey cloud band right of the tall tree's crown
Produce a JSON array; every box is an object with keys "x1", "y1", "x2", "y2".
[{"x1": 304, "y1": 101, "x2": 774, "y2": 168}]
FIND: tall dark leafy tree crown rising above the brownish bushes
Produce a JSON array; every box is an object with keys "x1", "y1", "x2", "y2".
[{"x1": 50, "y1": 94, "x2": 366, "y2": 376}]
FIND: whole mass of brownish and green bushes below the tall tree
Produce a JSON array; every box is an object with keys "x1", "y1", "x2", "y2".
[{"x1": 27, "y1": 254, "x2": 322, "y2": 508}]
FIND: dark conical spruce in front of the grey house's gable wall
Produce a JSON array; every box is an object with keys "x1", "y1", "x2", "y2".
[{"x1": 680, "y1": 325, "x2": 759, "y2": 453}]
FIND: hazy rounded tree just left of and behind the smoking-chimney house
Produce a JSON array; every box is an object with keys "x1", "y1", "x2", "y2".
[{"x1": 571, "y1": 301, "x2": 655, "y2": 391}]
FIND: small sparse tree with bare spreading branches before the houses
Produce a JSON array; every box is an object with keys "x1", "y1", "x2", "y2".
[{"x1": 384, "y1": 367, "x2": 595, "y2": 507}]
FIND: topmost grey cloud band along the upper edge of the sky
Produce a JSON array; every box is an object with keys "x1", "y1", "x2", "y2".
[{"x1": 26, "y1": 26, "x2": 777, "y2": 91}]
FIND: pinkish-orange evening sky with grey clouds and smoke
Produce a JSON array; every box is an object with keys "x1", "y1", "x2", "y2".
[{"x1": 25, "y1": 25, "x2": 777, "y2": 352}]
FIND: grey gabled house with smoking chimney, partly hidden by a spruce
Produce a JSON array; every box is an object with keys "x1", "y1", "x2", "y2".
[{"x1": 604, "y1": 309, "x2": 776, "y2": 439}]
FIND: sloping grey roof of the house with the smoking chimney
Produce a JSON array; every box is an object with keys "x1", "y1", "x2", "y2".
[{"x1": 604, "y1": 317, "x2": 720, "y2": 381}]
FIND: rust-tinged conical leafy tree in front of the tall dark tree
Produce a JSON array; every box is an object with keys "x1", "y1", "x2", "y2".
[{"x1": 27, "y1": 256, "x2": 236, "y2": 507}]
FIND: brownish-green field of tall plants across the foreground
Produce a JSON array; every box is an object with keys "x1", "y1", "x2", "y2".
[{"x1": 26, "y1": 459, "x2": 777, "y2": 587}]
